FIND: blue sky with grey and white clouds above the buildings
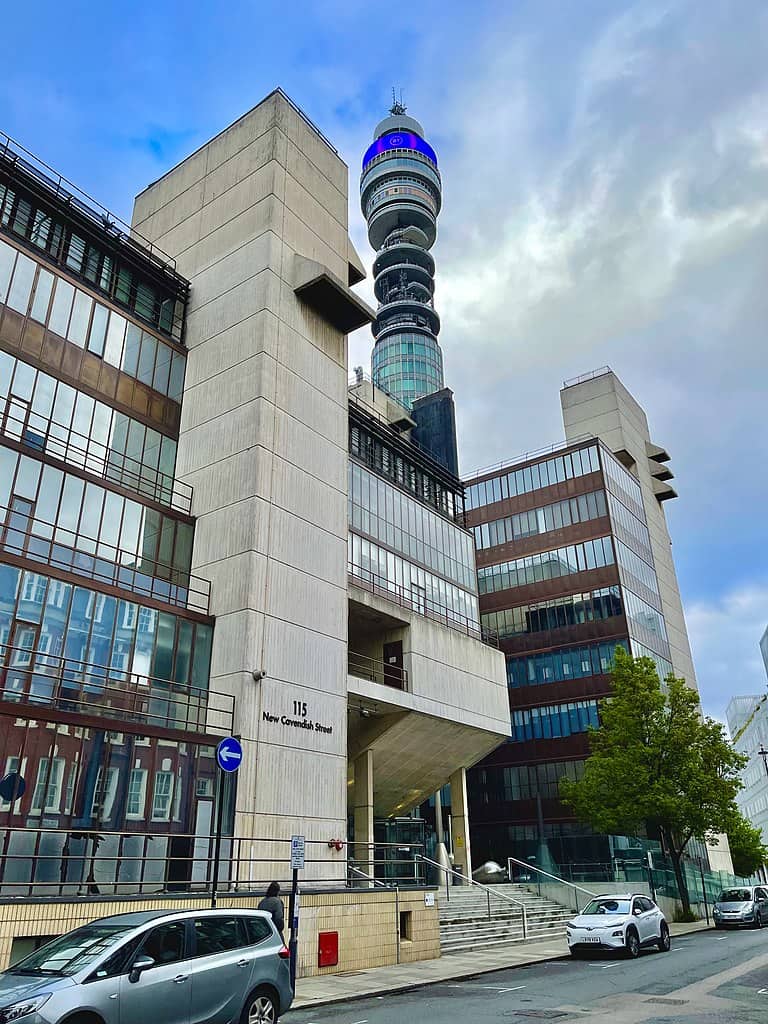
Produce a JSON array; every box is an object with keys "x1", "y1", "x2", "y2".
[{"x1": 0, "y1": 0, "x2": 768, "y2": 716}]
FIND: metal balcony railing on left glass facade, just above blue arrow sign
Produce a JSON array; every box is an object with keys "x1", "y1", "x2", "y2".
[{"x1": 0, "y1": 644, "x2": 234, "y2": 735}]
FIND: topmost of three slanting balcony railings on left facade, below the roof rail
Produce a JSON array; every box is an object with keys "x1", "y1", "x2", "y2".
[{"x1": 0, "y1": 397, "x2": 193, "y2": 515}]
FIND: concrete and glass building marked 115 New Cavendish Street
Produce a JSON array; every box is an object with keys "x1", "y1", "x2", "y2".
[{"x1": 0, "y1": 90, "x2": 509, "y2": 973}]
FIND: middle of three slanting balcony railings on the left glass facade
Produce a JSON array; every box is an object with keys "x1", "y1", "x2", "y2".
[{"x1": 0, "y1": 505, "x2": 211, "y2": 614}]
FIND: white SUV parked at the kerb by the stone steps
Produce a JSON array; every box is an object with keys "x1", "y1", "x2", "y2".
[{"x1": 565, "y1": 893, "x2": 670, "y2": 957}]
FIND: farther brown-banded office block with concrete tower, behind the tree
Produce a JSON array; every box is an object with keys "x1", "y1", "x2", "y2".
[{"x1": 467, "y1": 369, "x2": 708, "y2": 872}]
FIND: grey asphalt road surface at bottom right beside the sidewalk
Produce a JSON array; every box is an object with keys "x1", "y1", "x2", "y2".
[{"x1": 285, "y1": 929, "x2": 768, "y2": 1024}]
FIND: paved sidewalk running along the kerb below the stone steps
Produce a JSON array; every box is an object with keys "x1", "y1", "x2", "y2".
[{"x1": 292, "y1": 922, "x2": 709, "y2": 1010}]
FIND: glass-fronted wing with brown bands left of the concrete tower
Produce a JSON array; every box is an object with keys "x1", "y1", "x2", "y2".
[{"x1": 0, "y1": 134, "x2": 232, "y2": 896}]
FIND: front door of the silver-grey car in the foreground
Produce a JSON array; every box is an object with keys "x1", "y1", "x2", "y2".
[{"x1": 120, "y1": 921, "x2": 191, "y2": 1024}]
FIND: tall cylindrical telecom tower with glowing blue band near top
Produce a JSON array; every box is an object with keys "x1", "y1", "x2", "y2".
[{"x1": 360, "y1": 102, "x2": 443, "y2": 409}]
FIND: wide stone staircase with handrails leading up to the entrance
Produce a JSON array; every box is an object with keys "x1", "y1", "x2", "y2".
[{"x1": 437, "y1": 885, "x2": 574, "y2": 955}]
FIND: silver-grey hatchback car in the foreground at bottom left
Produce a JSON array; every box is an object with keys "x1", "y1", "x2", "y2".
[{"x1": 0, "y1": 909, "x2": 293, "y2": 1024}]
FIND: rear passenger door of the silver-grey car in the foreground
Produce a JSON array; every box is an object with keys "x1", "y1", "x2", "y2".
[{"x1": 191, "y1": 912, "x2": 253, "y2": 1024}]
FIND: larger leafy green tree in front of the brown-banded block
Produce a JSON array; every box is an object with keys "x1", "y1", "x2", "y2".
[{"x1": 560, "y1": 647, "x2": 746, "y2": 913}]
